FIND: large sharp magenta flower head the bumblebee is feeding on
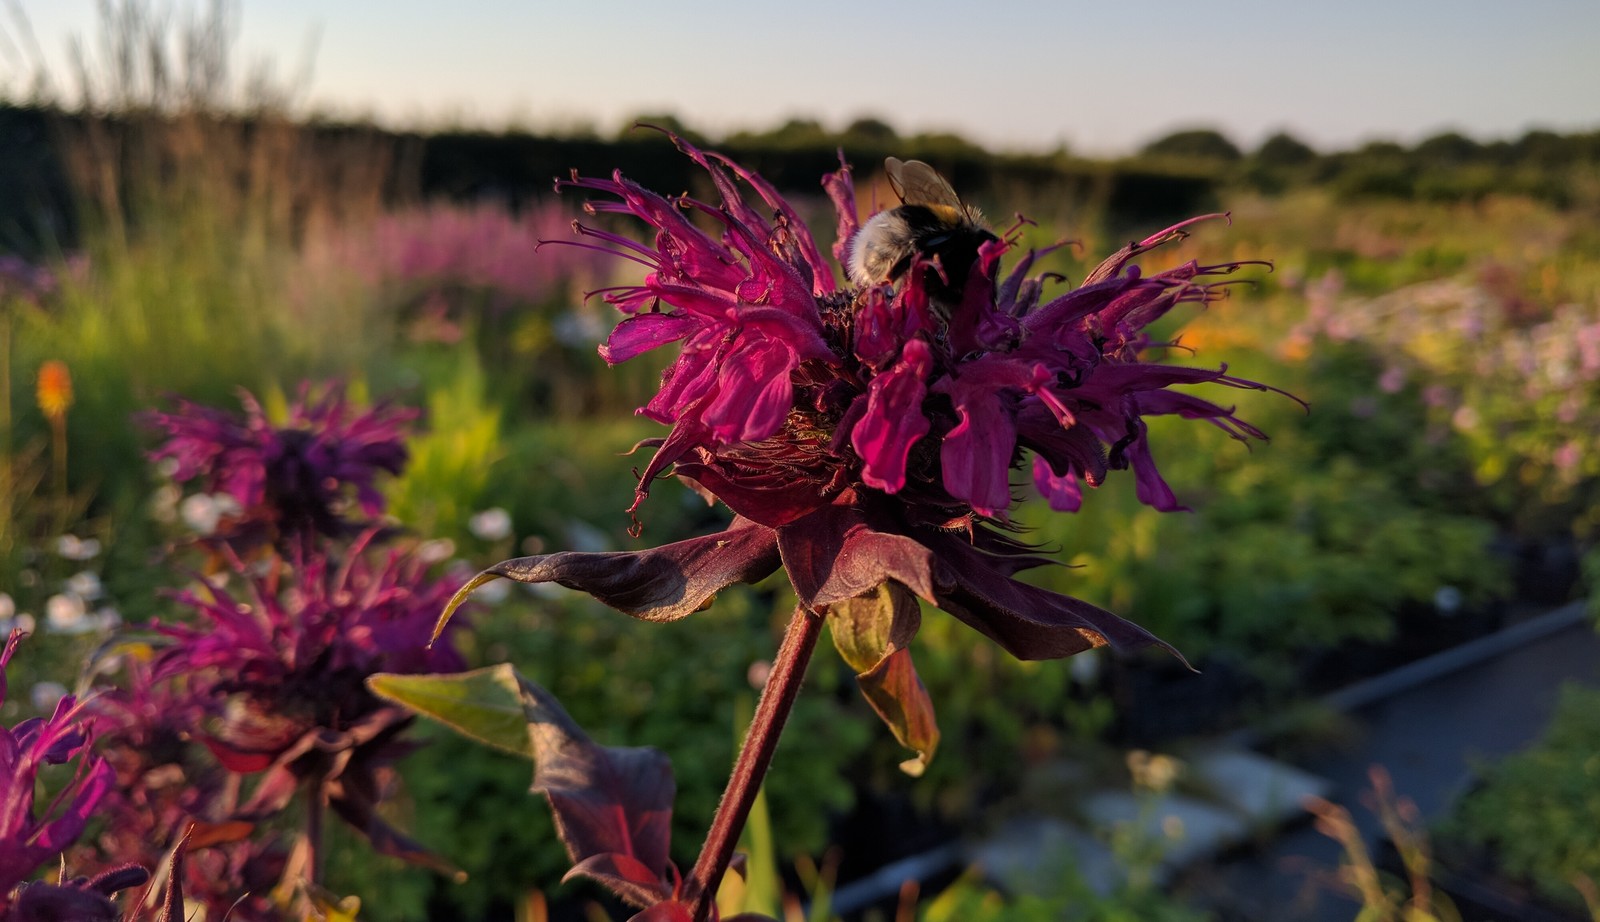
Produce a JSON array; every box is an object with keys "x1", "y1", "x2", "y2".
[{"x1": 562, "y1": 141, "x2": 1264, "y2": 528}]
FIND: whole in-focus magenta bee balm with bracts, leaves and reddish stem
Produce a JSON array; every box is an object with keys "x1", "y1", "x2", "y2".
[{"x1": 373, "y1": 131, "x2": 1275, "y2": 922}]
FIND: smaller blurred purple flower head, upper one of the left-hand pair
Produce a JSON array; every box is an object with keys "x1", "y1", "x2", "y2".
[{"x1": 147, "y1": 386, "x2": 416, "y2": 547}]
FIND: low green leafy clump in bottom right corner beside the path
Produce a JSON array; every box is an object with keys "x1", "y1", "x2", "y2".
[{"x1": 1445, "y1": 685, "x2": 1600, "y2": 906}]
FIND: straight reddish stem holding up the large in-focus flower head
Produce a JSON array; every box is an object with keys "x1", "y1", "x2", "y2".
[{"x1": 683, "y1": 605, "x2": 822, "y2": 922}]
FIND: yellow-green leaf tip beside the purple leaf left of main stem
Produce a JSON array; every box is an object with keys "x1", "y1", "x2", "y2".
[{"x1": 366, "y1": 663, "x2": 533, "y2": 759}]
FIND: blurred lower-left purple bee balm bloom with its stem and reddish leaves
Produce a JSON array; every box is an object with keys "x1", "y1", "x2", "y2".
[{"x1": 73, "y1": 531, "x2": 462, "y2": 920}]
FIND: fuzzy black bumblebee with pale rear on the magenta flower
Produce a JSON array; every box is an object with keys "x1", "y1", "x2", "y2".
[{"x1": 846, "y1": 157, "x2": 998, "y2": 320}]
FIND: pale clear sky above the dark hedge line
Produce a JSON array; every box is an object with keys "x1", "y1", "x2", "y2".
[{"x1": 0, "y1": 0, "x2": 1600, "y2": 154}]
